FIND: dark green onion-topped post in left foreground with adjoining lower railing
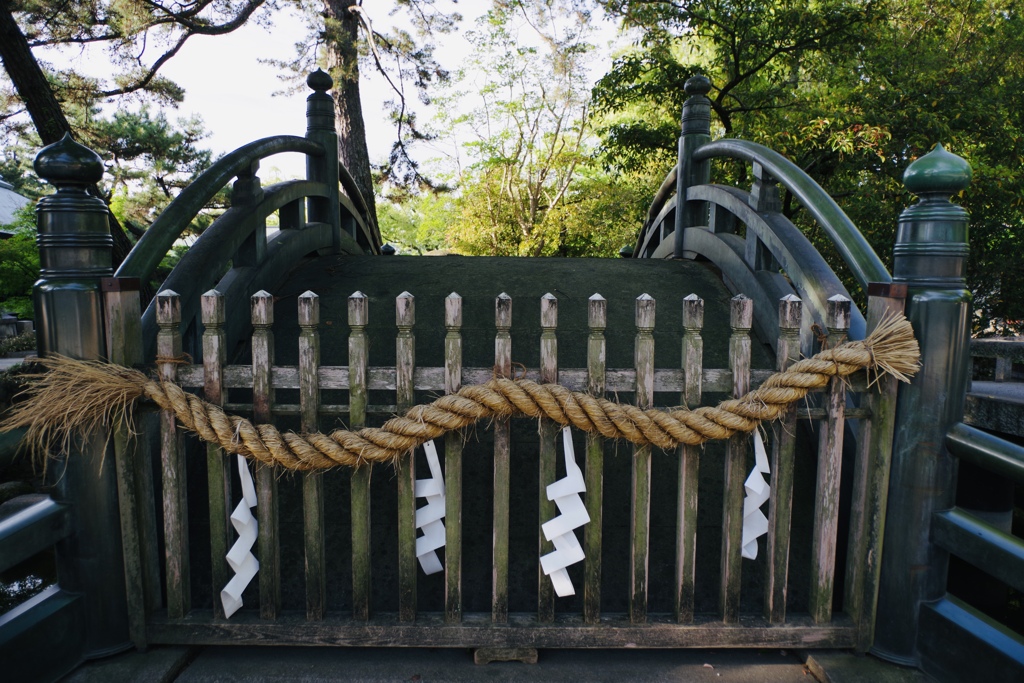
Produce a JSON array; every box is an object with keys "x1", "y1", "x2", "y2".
[{"x1": 0, "y1": 136, "x2": 131, "y2": 680}]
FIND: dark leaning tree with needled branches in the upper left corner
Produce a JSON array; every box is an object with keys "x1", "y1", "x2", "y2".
[{"x1": 0, "y1": 0, "x2": 262, "y2": 265}]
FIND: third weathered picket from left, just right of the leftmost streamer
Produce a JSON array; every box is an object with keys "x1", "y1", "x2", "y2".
[{"x1": 251, "y1": 290, "x2": 281, "y2": 620}]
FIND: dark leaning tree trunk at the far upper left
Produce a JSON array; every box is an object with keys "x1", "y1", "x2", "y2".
[{"x1": 0, "y1": 0, "x2": 132, "y2": 270}]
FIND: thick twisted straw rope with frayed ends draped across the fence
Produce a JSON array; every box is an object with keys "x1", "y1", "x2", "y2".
[{"x1": 2, "y1": 315, "x2": 920, "y2": 470}]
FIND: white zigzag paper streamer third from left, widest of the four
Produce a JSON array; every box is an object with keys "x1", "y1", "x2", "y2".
[{"x1": 541, "y1": 427, "x2": 590, "y2": 598}]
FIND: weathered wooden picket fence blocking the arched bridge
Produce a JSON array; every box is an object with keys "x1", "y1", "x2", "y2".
[{"x1": 106, "y1": 288, "x2": 903, "y2": 649}]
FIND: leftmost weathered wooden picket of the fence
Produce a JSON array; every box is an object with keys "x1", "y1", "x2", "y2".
[{"x1": 157, "y1": 290, "x2": 191, "y2": 618}]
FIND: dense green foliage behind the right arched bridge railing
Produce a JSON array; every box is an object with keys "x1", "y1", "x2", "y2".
[{"x1": 594, "y1": 0, "x2": 1024, "y2": 331}]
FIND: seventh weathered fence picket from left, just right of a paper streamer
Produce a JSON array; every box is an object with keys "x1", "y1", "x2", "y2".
[{"x1": 444, "y1": 292, "x2": 462, "y2": 624}]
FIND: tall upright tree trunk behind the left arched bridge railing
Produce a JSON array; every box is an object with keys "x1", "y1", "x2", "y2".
[{"x1": 323, "y1": 0, "x2": 377, "y2": 224}]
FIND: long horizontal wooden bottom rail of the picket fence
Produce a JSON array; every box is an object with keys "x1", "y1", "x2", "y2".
[{"x1": 148, "y1": 610, "x2": 856, "y2": 649}]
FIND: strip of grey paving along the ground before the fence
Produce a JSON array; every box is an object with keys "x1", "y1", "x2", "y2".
[{"x1": 63, "y1": 646, "x2": 929, "y2": 683}]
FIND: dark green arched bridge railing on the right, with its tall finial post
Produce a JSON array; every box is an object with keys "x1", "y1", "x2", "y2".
[{"x1": 633, "y1": 84, "x2": 891, "y2": 354}]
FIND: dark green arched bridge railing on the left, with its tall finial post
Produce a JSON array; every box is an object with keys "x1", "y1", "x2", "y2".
[{"x1": 117, "y1": 71, "x2": 381, "y2": 359}]
